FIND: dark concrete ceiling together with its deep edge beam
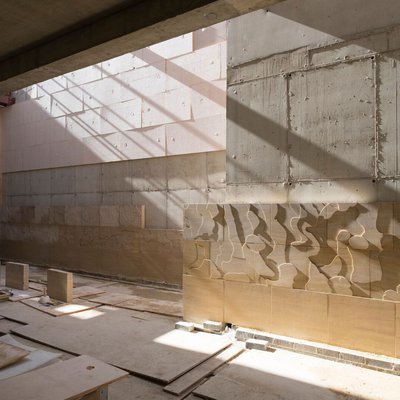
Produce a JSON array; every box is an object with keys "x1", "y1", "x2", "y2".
[{"x1": 0, "y1": 0, "x2": 282, "y2": 94}]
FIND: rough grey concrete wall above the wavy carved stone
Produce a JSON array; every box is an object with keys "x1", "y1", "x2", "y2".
[{"x1": 226, "y1": 0, "x2": 400, "y2": 203}]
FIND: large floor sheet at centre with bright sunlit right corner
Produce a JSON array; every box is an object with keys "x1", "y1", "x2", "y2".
[{"x1": 14, "y1": 306, "x2": 229, "y2": 383}]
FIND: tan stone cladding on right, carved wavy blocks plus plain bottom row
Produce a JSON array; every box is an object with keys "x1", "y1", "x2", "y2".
[{"x1": 183, "y1": 202, "x2": 400, "y2": 357}]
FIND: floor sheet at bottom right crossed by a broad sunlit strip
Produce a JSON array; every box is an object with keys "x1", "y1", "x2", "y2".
[{"x1": 194, "y1": 350, "x2": 400, "y2": 400}]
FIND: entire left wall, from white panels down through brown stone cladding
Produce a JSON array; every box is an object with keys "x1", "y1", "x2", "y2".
[{"x1": 0, "y1": 23, "x2": 226, "y2": 285}]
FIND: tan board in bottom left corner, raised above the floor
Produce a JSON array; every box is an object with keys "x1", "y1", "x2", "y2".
[{"x1": 0, "y1": 356, "x2": 128, "y2": 400}]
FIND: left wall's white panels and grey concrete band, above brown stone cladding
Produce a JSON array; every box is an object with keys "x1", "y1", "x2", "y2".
[{"x1": 0, "y1": 23, "x2": 226, "y2": 229}]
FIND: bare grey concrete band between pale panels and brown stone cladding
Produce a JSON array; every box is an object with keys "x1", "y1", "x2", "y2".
[{"x1": 4, "y1": 151, "x2": 225, "y2": 229}]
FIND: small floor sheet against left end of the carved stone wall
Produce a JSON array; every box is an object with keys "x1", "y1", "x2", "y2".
[{"x1": 117, "y1": 296, "x2": 183, "y2": 317}]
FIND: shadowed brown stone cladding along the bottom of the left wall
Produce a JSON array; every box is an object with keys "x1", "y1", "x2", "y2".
[{"x1": 0, "y1": 206, "x2": 182, "y2": 286}]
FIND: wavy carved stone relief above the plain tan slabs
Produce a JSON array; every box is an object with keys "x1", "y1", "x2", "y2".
[{"x1": 184, "y1": 203, "x2": 400, "y2": 301}]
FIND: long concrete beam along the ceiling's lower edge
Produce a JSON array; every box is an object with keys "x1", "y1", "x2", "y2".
[{"x1": 0, "y1": 0, "x2": 282, "y2": 94}]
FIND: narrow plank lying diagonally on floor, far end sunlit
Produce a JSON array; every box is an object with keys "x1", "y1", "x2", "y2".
[{"x1": 164, "y1": 343, "x2": 244, "y2": 396}]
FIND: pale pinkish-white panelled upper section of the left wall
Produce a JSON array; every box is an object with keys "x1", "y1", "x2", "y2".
[{"x1": 2, "y1": 23, "x2": 226, "y2": 172}]
